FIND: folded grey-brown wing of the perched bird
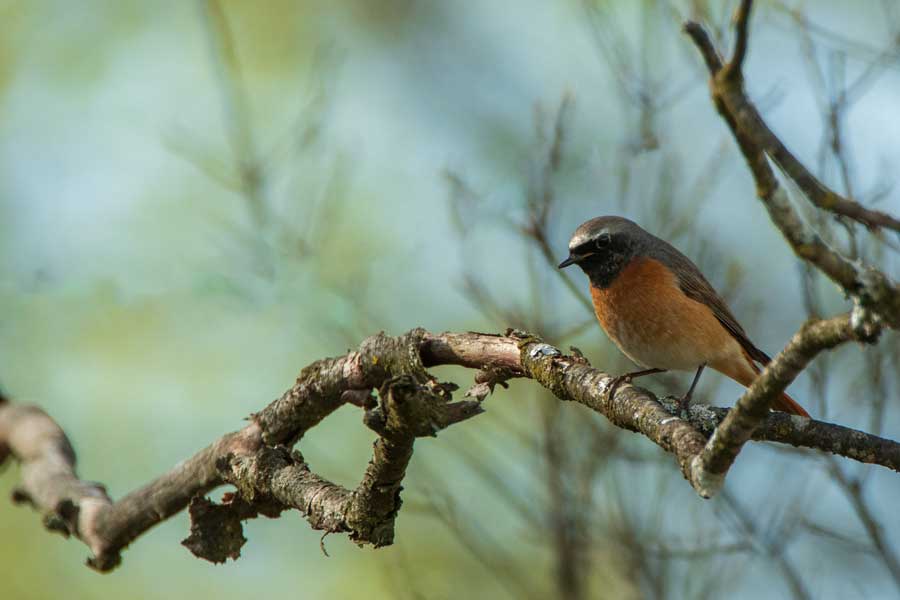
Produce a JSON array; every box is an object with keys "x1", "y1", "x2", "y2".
[{"x1": 652, "y1": 238, "x2": 772, "y2": 365}]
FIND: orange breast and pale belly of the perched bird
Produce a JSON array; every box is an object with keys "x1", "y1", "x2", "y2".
[{"x1": 591, "y1": 258, "x2": 743, "y2": 370}]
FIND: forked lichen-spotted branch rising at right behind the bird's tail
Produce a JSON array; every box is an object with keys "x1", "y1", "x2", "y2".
[{"x1": 684, "y1": 0, "x2": 900, "y2": 496}]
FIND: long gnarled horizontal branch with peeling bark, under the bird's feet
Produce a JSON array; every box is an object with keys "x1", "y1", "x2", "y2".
[{"x1": 0, "y1": 329, "x2": 900, "y2": 571}]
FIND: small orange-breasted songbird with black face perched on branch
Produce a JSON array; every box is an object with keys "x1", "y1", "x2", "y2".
[{"x1": 559, "y1": 216, "x2": 809, "y2": 417}]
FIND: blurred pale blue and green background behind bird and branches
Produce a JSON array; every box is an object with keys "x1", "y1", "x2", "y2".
[{"x1": 0, "y1": 0, "x2": 900, "y2": 599}]
